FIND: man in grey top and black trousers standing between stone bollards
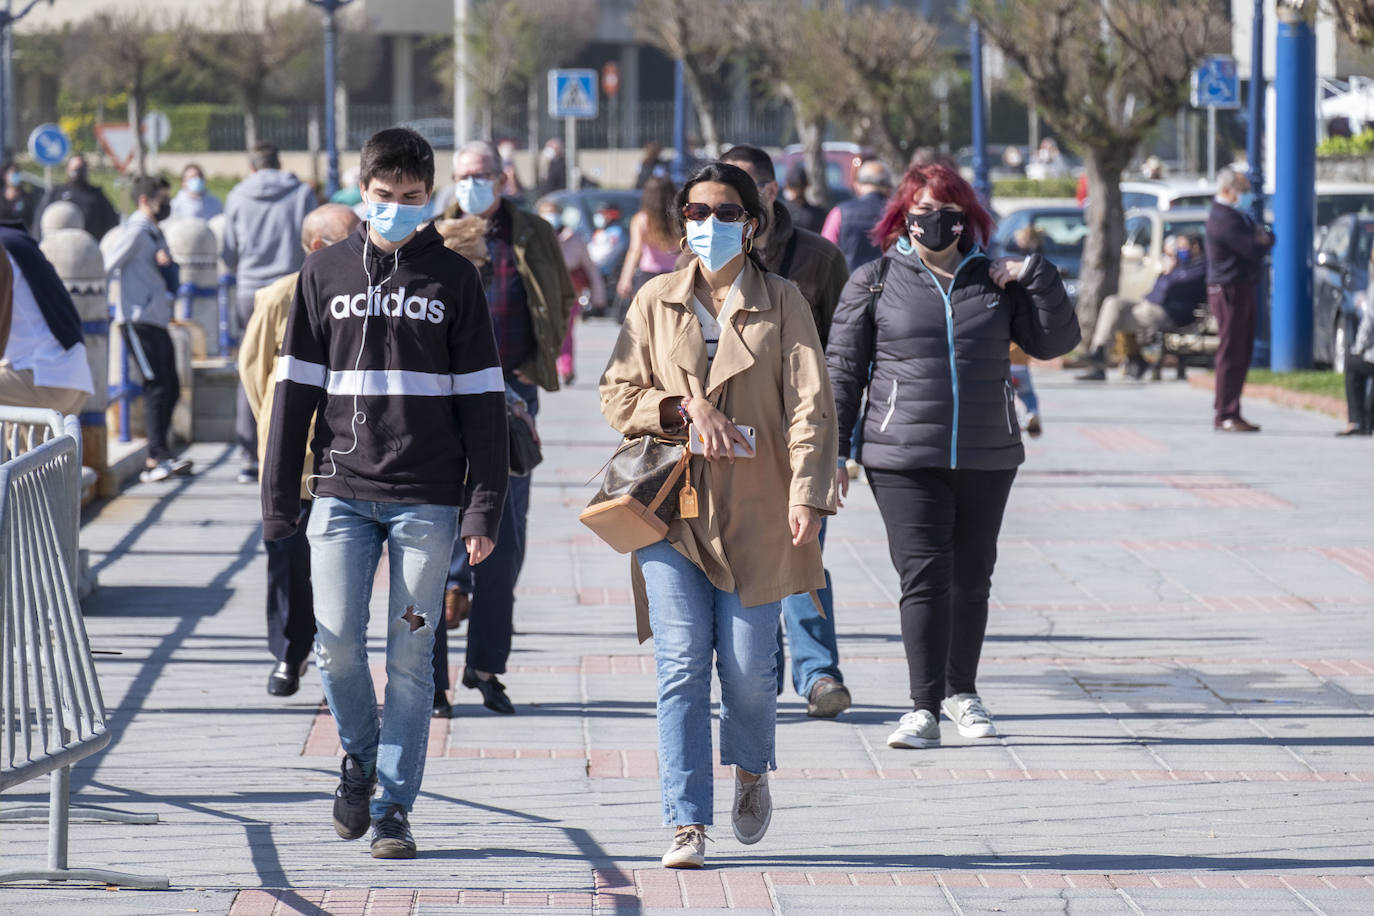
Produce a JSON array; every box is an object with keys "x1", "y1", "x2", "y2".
[{"x1": 104, "y1": 176, "x2": 191, "y2": 483}]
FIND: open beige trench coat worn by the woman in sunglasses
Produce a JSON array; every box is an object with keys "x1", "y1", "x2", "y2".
[{"x1": 600, "y1": 260, "x2": 838, "y2": 641}]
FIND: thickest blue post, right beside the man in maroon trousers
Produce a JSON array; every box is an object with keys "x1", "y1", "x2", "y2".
[{"x1": 1270, "y1": 0, "x2": 1316, "y2": 372}]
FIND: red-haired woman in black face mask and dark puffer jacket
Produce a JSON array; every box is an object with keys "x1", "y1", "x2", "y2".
[{"x1": 826, "y1": 163, "x2": 1079, "y2": 747}]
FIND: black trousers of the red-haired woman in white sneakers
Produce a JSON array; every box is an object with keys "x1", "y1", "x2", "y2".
[{"x1": 868, "y1": 468, "x2": 1017, "y2": 718}]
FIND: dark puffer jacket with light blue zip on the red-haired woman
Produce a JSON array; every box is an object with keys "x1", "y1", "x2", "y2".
[{"x1": 826, "y1": 251, "x2": 1080, "y2": 471}]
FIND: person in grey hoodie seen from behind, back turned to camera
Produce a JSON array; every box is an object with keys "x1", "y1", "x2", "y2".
[{"x1": 220, "y1": 143, "x2": 317, "y2": 483}]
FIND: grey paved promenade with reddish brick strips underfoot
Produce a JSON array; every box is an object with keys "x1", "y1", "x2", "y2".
[{"x1": 0, "y1": 323, "x2": 1374, "y2": 916}]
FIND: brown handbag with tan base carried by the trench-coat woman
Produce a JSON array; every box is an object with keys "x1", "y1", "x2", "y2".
[{"x1": 577, "y1": 435, "x2": 697, "y2": 553}]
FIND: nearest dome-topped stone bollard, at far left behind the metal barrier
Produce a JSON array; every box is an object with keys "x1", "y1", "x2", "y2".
[{"x1": 40, "y1": 226, "x2": 110, "y2": 493}]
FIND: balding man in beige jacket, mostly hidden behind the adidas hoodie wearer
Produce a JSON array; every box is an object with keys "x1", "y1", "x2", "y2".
[{"x1": 239, "y1": 203, "x2": 359, "y2": 696}]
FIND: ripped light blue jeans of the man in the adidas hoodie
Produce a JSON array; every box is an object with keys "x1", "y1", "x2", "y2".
[{"x1": 306, "y1": 497, "x2": 458, "y2": 818}]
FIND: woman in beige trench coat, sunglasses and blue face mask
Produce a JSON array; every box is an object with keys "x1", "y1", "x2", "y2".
[{"x1": 600, "y1": 162, "x2": 837, "y2": 868}]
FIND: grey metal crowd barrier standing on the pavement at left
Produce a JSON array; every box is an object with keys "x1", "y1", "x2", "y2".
[{"x1": 0, "y1": 408, "x2": 168, "y2": 887}]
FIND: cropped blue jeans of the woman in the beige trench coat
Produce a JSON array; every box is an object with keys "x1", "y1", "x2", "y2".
[{"x1": 635, "y1": 541, "x2": 780, "y2": 827}]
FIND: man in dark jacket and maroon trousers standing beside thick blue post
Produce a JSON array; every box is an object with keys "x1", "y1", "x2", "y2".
[{"x1": 1206, "y1": 169, "x2": 1274, "y2": 433}]
